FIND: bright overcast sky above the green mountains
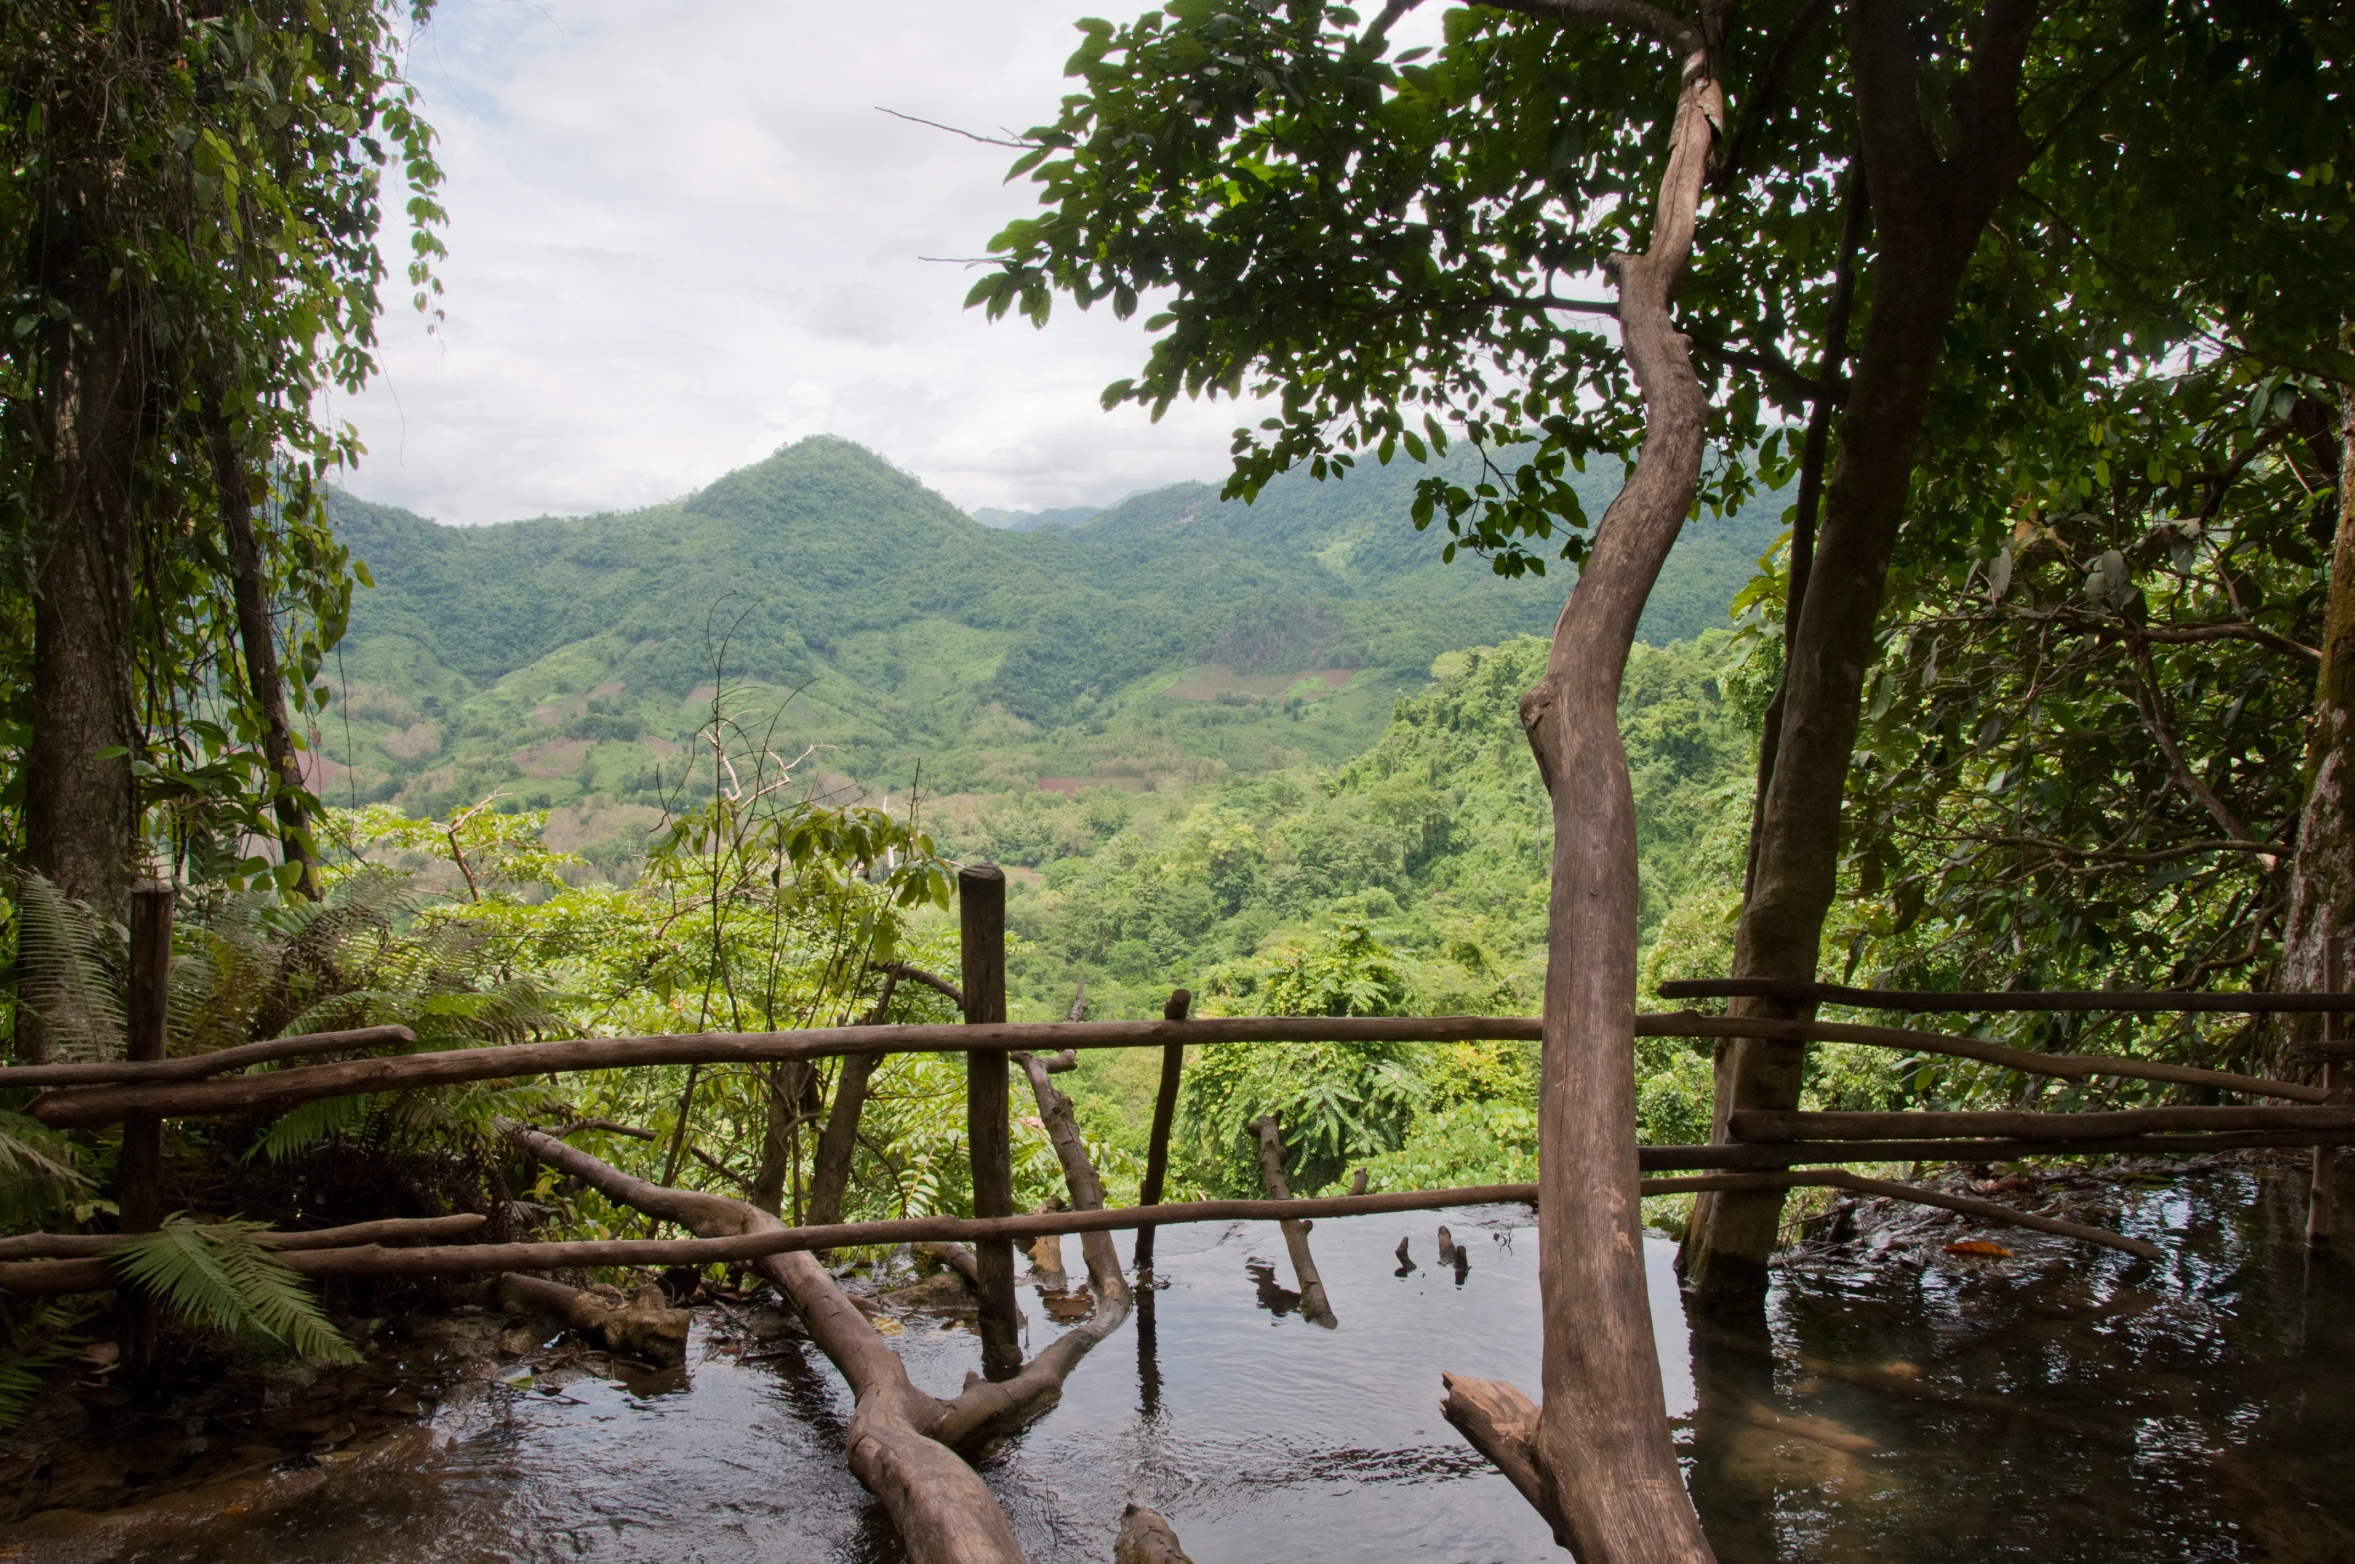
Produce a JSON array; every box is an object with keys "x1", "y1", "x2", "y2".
[{"x1": 334, "y1": 0, "x2": 1439, "y2": 523}]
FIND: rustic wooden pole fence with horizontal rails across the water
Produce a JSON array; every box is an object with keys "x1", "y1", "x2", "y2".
[{"x1": 0, "y1": 867, "x2": 2355, "y2": 1290}]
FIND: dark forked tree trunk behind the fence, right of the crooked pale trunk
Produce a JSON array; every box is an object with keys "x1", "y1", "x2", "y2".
[{"x1": 1684, "y1": 0, "x2": 2035, "y2": 1307}]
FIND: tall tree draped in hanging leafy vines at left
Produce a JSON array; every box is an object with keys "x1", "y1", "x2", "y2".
[{"x1": 0, "y1": 0, "x2": 440, "y2": 942}]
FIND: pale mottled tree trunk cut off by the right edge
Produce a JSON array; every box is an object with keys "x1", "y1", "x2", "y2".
[{"x1": 2282, "y1": 360, "x2": 2355, "y2": 1003}]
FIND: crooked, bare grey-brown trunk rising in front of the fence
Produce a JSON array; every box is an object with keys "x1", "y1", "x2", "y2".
[{"x1": 1460, "y1": 27, "x2": 1724, "y2": 1564}]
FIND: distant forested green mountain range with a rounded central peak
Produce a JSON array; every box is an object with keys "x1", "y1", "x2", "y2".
[{"x1": 316, "y1": 438, "x2": 1780, "y2": 841}]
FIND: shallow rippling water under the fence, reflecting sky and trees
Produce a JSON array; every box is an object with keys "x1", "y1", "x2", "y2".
[{"x1": 18, "y1": 1154, "x2": 2355, "y2": 1564}]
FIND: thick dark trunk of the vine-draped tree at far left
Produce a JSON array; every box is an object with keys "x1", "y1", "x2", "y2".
[{"x1": 24, "y1": 287, "x2": 141, "y2": 946}]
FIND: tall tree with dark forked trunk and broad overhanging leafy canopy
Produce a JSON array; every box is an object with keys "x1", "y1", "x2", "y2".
[{"x1": 973, "y1": 0, "x2": 2346, "y2": 1307}]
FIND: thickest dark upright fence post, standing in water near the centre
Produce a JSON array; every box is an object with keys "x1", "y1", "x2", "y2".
[{"x1": 956, "y1": 864, "x2": 1022, "y2": 1380}]
